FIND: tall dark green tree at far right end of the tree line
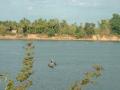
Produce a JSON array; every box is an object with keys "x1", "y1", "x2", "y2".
[{"x1": 110, "y1": 14, "x2": 120, "y2": 35}]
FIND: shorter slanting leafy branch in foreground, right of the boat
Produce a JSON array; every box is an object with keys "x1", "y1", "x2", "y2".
[{"x1": 70, "y1": 65, "x2": 103, "y2": 90}]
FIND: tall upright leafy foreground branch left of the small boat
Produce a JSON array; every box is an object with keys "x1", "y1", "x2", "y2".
[{"x1": 5, "y1": 42, "x2": 34, "y2": 90}]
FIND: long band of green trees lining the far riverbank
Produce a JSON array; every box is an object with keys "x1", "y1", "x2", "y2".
[{"x1": 0, "y1": 14, "x2": 120, "y2": 38}]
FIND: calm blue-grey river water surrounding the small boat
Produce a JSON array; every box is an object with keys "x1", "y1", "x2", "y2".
[{"x1": 0, "y1": 40, "x2": 120, "y2": 90}]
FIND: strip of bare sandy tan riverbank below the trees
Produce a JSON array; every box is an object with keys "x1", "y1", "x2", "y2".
[{"x1": 0, "y1": 34, "x2": 120, "y2": 41}]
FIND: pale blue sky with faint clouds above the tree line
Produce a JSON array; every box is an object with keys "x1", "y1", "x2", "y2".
[{"x1": 0, "y1": 0, "x2": 120, "y2": 23}]
